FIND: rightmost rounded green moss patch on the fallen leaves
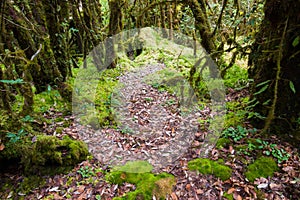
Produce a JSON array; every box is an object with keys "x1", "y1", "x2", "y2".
[{"x1": 245, "y1": 157, "x2": 278, "y2": 182}]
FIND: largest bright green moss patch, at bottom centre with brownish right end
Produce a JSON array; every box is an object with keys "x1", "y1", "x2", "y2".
[{"x1": 106, "y1": 161, "x2": 176, "y2": 200}]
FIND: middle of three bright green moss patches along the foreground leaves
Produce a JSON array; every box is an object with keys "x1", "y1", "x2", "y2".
[{"x1": 188, "y1": 158, "x2": 232, "y2": 181}]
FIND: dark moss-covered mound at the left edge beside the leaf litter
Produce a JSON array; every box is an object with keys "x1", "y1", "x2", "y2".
[{"x1": 0, "y1": 135, "x2": 89, "y2": 174}]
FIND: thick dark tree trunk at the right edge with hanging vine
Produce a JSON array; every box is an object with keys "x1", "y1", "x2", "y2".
[{"x1": 249, "y1": 0, "x2": 300, "y2": 141}]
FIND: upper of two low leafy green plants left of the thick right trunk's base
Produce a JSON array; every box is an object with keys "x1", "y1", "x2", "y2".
[{"x1": 222, "y1": 126, "x2": 256, "y2": 142}]
